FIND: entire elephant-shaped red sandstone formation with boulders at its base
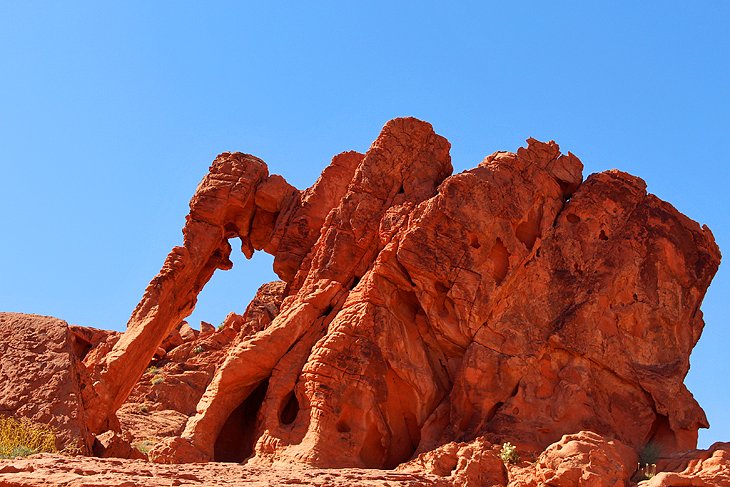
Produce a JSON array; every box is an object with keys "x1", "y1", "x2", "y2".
[{"x1": 0, "y1": 118, "x2": 725, "y2": 486}]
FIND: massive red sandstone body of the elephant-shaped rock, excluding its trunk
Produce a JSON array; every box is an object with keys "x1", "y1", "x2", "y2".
[{"x1": 144, "y1": 120, "x2": 719, "y2": 467}]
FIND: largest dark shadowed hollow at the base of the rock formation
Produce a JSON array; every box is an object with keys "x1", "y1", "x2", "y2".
[{"x1": 213, "y1": 379, "x2": 269, "y2": 463}]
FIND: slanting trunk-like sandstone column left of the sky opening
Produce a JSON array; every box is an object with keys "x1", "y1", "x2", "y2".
[{"x1": 85, "y1": 153, "x2": 268, "y2": 433}]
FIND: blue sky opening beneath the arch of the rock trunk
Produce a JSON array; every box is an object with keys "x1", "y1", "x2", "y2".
[{"x1": 185, "y1": 244, "x2": 279, "y2": 329}]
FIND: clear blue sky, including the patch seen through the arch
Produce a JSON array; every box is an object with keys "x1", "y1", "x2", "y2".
[{"x1": 0, "y1": 0, "x2": 730, "y2": 446}]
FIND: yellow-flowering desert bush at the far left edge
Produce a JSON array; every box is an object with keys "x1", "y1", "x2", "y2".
[{"x1": 0, "y1": 417, "x2": 58, "y2": 458}]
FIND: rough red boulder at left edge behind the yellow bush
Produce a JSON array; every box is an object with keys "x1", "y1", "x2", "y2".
[{"x1": 0, "y1": 313, "x2": 93, "y2": 453}]
